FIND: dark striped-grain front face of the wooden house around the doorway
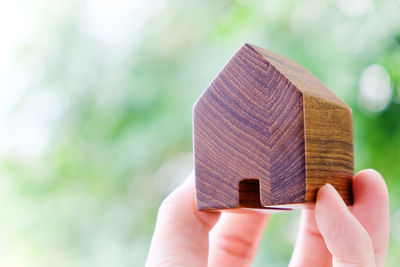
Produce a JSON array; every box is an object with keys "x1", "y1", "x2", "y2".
[{"x1": 194, "y1": 46, "x2": 306, "y2": 209}]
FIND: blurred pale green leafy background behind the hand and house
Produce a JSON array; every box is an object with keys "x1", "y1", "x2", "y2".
[{"x1": 0, "y1": 0, "x2": 400, "y2": 267}]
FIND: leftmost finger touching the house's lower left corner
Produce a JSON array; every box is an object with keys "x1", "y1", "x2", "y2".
[{"x1": 146, "y1": 176, "x2": 219, "y2": 267}]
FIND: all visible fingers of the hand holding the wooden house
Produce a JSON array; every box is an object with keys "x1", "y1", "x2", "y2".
[{"x1": 146, "y1": 170, "x2": 389, "y2": 267}]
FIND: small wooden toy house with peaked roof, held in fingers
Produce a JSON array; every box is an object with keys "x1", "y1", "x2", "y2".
[{"x1": 193, "y1": 44, "x2": 353, "y2": 210}]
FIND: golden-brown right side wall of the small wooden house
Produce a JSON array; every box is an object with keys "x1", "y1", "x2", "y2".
[{"x1": 304, "y1": 95, "x2": 354, "y2": 205}]
